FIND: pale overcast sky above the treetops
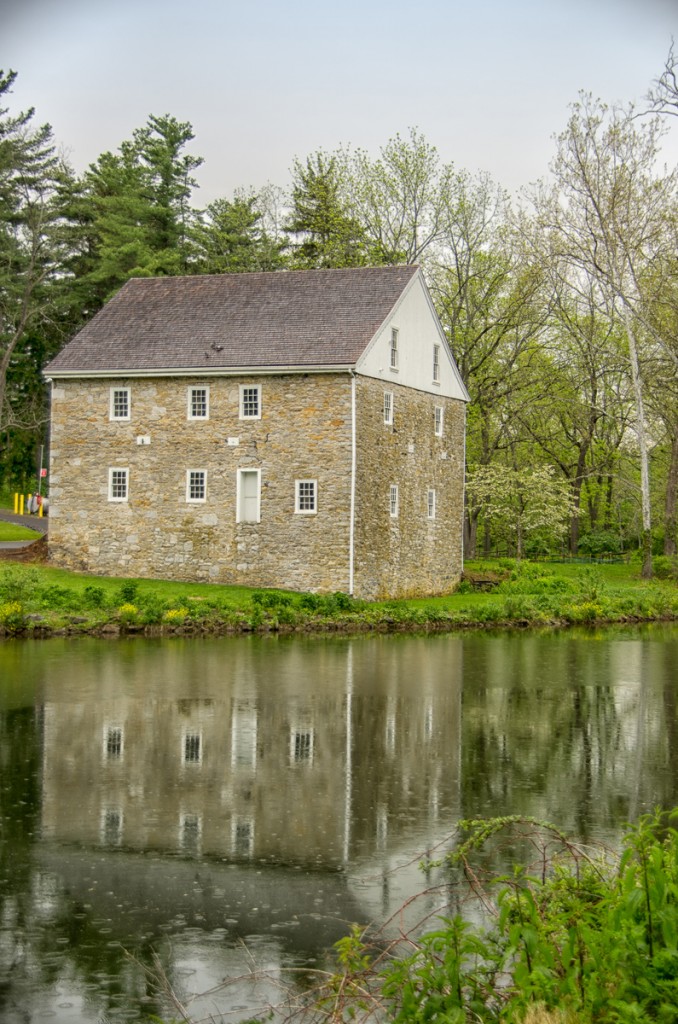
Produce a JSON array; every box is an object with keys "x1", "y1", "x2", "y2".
[{"x1": 0, "y1": 0, "x2": 678, "y2": 205}]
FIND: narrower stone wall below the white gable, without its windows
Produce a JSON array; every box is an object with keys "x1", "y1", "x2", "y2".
[{"x1": 355, "y1": 377, "x2": 465, "y2": 598}]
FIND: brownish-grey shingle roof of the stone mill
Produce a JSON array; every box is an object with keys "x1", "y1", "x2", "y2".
[{"x1": 45, "y1": 266, "x2": 419, "y2": 375}]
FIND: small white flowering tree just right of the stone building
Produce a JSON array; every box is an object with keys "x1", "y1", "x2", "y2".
[{"x1": 466, "y1": 465, "x2": 574, "y2": 558}]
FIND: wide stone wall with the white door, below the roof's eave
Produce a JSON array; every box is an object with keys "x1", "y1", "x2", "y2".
[{"x1": 49, "y1": 375, "x2": 351, "y2": 591}]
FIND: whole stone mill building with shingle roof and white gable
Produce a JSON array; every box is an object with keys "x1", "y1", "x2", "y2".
[{"x1": 45, "y1": 266, "x2": 468, "y2": 599}]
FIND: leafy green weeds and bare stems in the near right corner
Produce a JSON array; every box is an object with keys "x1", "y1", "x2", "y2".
[{"x1": 150, "y1": 811, "x2": 678, "y2": 1024}]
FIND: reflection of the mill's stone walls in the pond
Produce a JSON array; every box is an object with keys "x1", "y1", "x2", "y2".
[{"x1": 42, "y1": 638, "x2": 461, "y2": 869}]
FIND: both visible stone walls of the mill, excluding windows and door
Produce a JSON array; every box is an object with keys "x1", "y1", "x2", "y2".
[{"x1": 49, "y1": 374, "x2": 463, "y2": 598}]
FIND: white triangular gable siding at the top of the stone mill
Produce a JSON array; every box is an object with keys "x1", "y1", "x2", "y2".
[{"x1": 355, "y1": 275, "x2": 468, "y2": 401}]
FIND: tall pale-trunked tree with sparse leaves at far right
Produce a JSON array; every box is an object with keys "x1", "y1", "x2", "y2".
[{"x1": 534, "y1": 96, "x2": 678, "y2": 578}]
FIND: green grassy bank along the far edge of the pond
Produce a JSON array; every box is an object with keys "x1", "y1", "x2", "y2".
[{"x1": 0, "y1": 559, "x2": 678, "y2": 636}]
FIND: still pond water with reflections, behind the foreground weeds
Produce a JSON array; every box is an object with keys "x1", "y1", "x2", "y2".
[{"x1": 0, "y1": 627, "x2": 678, "y2": 1024}]
